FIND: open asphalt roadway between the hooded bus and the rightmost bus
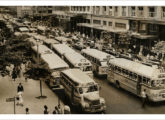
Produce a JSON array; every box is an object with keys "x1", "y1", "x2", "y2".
[{"x1": 71, "y1": 47, "x2": 165, "y2": 114}]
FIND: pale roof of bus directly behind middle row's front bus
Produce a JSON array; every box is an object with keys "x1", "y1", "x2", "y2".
[{"x1": 53, "y1": 44, "x2": 75, "y2": 55}]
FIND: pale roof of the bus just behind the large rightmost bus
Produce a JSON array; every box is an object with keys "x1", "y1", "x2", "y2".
[{"x1": 82, "y1": 48, "x2": 110, "y2": 61}]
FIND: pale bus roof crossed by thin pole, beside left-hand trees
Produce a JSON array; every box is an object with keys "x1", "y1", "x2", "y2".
[{"x1": 32, "y1": 45, "x2": 54, "y2": 55}]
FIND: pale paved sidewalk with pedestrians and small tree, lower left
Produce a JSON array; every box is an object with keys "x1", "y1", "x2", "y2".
[{"x1": 0, "y1": 76, "x2": 64, "y2": 114}]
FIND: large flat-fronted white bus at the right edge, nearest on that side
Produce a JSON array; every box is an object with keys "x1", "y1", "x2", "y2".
[{"x1": 107, "y1": 58, "x2": 165, "y2": 102}]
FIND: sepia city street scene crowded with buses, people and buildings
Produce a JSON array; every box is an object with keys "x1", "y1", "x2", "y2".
[{"x1": 0, "y1": 6, "x2": 165, "y2": 114}]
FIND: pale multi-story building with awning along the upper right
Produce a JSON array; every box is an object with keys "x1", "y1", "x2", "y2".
[{"x1": 70, "y1": 6, "x2": 165, "y2": 47}]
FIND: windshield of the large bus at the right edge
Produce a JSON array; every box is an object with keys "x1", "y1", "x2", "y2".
[{"x1": 151, "y1": 79, "x2": 165, "y2": 89}]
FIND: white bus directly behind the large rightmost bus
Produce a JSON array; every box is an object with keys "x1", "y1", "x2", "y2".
[{"x1": 81, "y1": 48, "x2": 110, "y2": 76}]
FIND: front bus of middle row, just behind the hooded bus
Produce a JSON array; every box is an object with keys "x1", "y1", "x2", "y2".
[{"x1": 64, "y1": 52, "x2": 93, "y2": 77}]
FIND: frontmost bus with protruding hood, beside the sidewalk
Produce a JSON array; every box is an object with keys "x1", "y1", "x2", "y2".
[{"x1": 61, "y1": 69, "x2": 106, "y2": 113}]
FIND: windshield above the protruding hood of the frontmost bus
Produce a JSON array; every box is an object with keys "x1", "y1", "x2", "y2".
[{"x1": 78, "y1": 85, "x2": 99, "y2": 94}]
